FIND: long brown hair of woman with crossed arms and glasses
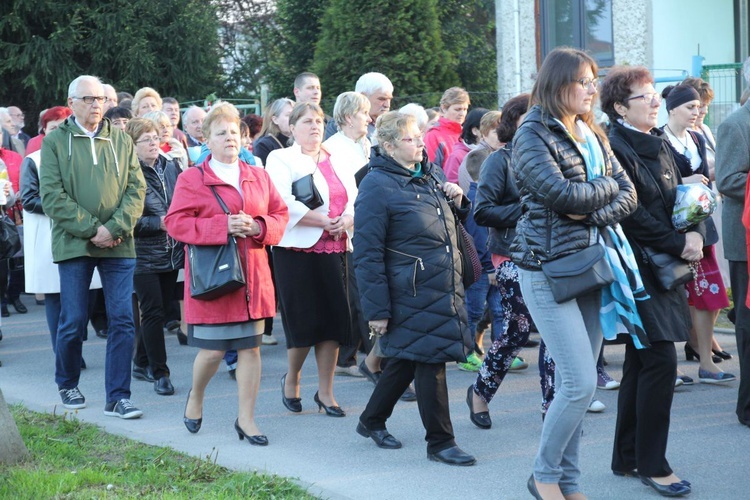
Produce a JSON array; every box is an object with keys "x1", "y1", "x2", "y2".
[{"x1": 531, "y1": 47, "x2": 607, "y2": 142}]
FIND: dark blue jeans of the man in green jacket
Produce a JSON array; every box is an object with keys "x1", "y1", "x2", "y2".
[{"x1": 55, "y1": 257, "x2": 135, "y2": 403}]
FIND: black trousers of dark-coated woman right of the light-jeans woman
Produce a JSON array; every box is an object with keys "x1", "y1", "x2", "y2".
[{"x1": 612, "y1": 342, "x2": 677, "y2": 477}]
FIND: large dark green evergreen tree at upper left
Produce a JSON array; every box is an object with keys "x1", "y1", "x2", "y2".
[{"x1": 0, "y1": 0, "x2": 222, "y2": 127}]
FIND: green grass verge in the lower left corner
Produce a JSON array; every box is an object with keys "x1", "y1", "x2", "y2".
[{"x1": 0, "y1": 405, "x2": 315, "y2": 499}]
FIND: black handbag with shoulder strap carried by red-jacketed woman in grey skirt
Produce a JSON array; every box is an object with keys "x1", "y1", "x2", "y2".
[{"x1": 188, "y1": 177, "x2": 245, "y2": 300}]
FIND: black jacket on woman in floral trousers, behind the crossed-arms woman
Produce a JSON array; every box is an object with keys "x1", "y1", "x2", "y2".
[{"x1": 474, "y1": 144, "x2": 521, "y2": 256}]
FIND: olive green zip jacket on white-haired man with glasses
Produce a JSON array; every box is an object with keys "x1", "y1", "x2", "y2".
[{"x1": 39, "y1": 116, "x2": 146, "y2": 262}]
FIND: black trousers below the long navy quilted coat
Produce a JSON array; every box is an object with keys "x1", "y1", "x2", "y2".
[{"x1": 359, "y1": 358, "x2": 456, "y2": 453}]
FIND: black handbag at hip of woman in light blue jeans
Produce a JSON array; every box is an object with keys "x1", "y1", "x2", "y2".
[{"x1": 542, "y1": 244, "x2": 615, "y2": 304}]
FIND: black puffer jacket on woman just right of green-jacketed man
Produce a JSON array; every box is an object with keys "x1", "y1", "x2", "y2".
[{"x1": 134, "y1": 155, "x2": 185, "y2": 274}]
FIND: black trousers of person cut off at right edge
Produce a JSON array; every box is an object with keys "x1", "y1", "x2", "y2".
[{"x1": 729, "y1": 260, "x2": 750, "y2": 427}]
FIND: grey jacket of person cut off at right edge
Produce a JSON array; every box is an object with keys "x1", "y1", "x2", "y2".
[{"x1": 716, "y1": 101, "x2": 750, "y2": 261}]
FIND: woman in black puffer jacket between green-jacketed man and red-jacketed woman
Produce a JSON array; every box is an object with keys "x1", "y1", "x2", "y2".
[{"x1": 127, "y1": 118, "x2": 185, "y2": 396}]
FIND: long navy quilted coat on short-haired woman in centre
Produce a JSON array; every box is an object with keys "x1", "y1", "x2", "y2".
[{"x1": 353, "y1": 148, "x2": 473, "y2": 363}]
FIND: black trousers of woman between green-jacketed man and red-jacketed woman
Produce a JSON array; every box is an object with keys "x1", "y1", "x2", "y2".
[{"x1": 133, "y1": 271, "x2": 177, "y2": 379}]
